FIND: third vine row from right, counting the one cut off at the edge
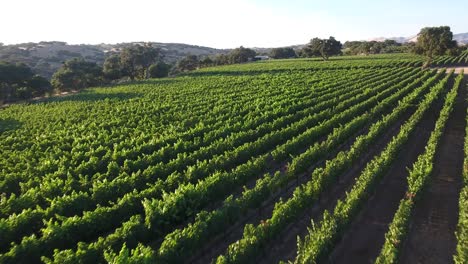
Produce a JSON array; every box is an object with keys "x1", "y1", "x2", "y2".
[{"x1": 295, "y1": 71, "x2": 451, "y2": 263}]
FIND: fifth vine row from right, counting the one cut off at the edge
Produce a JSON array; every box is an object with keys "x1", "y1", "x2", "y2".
[{"x1": 149, "y1": 69, "x2": 438, "y2": 262}]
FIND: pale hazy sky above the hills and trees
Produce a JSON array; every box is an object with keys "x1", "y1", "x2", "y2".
[{"x1": 0, "y1": 0, "x2": 468, "y2": 48}]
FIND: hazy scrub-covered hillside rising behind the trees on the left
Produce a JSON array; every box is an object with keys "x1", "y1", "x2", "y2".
[{"x1": 0, "y1": 41, "x2": 229, "y2": 78}]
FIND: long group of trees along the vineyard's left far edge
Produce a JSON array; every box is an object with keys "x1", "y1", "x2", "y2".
[{"x1": 0, "y1": 44, "x2": 256, "y2": 103}]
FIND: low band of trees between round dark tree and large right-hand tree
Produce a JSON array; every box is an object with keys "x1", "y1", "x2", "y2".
[{"x1": 343, "y1": 39, "x2": 410, "y2": 55}]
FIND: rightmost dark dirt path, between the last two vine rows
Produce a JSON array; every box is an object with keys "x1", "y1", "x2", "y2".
[{"x1": 401, "y1": 75, "x2": 468, "y2": 263}]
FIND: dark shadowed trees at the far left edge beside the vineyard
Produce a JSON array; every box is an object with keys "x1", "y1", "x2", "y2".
[{"x1": 0, "y1": 62, "x2": 52, "y2": 105}]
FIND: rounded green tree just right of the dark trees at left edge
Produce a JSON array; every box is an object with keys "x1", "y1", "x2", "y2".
[{"x1": 51, "y1": 58, "x2": 102, "y2": 91}]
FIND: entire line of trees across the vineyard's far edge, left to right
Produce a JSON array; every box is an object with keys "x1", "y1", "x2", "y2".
[{"x1": 0, "y1": 26, "x2": 467, "y2": 104}]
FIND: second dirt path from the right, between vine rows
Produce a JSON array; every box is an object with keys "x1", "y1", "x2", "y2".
[{"x1": 328, "y1": 77, "x2": 450, "y2": 263}]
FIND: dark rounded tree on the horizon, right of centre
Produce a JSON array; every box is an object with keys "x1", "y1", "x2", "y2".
[{"x1": 302, "y1": 37, "x2": 342, "y2": 60}]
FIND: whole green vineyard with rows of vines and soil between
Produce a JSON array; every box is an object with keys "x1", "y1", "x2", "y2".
[{"x1": 0, "y1": 52, "x2": 468, "y2": 263}]
